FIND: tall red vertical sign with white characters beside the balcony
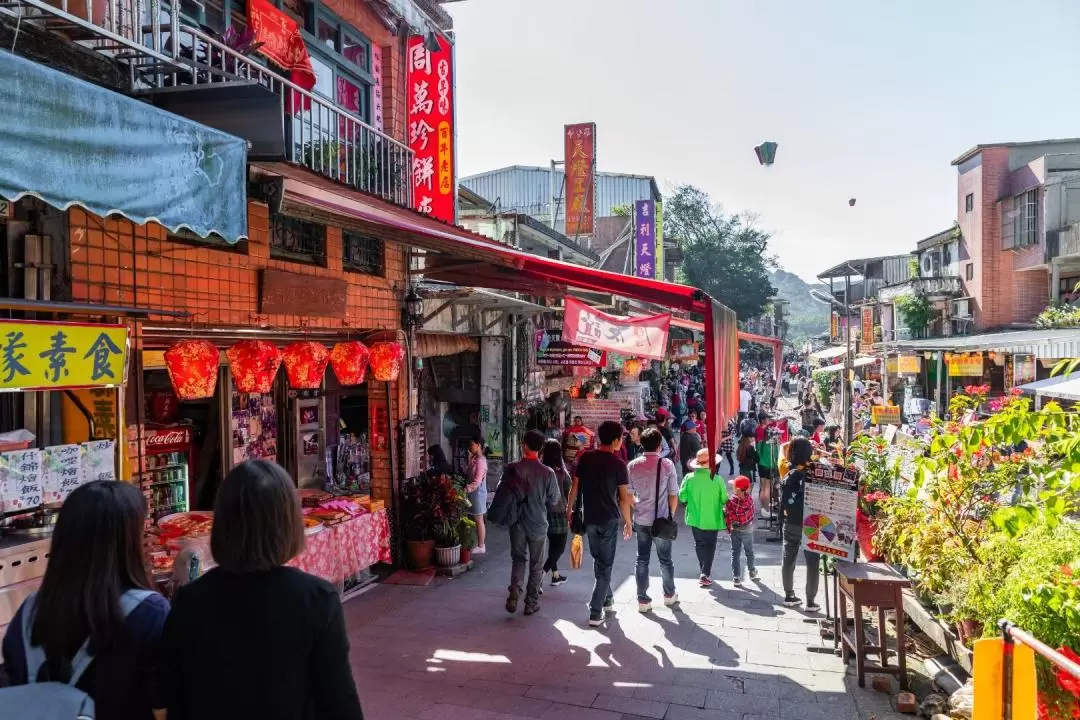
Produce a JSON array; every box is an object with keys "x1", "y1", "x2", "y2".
[{"x1": 406, "y1": 36, "x2": 457, "y2": 223}]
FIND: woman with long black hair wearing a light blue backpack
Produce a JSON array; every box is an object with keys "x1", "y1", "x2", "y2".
[{"x1": 3, "y1": 480, "x2": 168, "y2": 720}]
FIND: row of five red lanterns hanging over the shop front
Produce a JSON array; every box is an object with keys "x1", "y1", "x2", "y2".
[{"x1": 165, "y1": 340, "x2": 405, "y2": 400}]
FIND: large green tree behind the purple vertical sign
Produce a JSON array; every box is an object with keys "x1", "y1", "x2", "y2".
[{"x1": 664, "y1": 185, "x2": 777, "y2": 320}]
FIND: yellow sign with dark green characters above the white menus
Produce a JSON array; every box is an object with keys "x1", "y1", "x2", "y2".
[{"x1": 0, "y1": 321, "x2": 127, "y2": 390}]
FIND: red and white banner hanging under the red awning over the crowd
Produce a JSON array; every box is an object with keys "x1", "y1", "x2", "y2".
[{"x1": 563, "y1": 297, "x2": 672, "y2": 359}]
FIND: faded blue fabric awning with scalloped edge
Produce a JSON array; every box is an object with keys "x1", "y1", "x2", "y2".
[{"x1": 0, "y1": 51, "x2": 247, "y2": 243}]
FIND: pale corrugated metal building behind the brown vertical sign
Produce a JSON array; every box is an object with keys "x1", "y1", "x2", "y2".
[{"x1": 459, "y1": 165, "x2": 662, "y2": 231}]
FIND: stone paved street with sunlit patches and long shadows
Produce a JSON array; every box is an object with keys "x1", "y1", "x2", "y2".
[{"x1": 346, "y1": 496, "x2": 905, "y2": 720}]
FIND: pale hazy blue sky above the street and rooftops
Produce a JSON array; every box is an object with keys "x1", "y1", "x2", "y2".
[{"x1": 446, "y1": 0, "x2": 1080, "y2": 279}]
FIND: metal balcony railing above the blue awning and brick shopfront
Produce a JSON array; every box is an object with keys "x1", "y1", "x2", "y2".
[{"x1": 0, "y1": 0, "x2": 413, "y2": 207}]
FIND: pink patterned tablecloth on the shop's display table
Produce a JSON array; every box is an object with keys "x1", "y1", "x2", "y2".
[{"x1": 289, "y1": 510, "x2": 391, "y2": 583}]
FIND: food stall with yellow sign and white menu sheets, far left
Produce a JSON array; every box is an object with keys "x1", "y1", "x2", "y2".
[{"x1": 0, "y1": 315, "x2": 127, "y2": 635}]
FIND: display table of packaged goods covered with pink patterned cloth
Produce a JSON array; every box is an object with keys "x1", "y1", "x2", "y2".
[{"x1": 147, "y1": 490, "x2": 391, "y2": 589}]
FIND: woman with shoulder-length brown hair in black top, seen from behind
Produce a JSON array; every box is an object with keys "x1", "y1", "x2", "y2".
[{"x1": 164, "y1": 460, "x2": 364, "y2": 720}]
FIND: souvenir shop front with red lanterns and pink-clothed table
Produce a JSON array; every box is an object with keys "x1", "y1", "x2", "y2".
[{"x1": 139, "y1": 338, "x2": 404, "y2": 590}]
